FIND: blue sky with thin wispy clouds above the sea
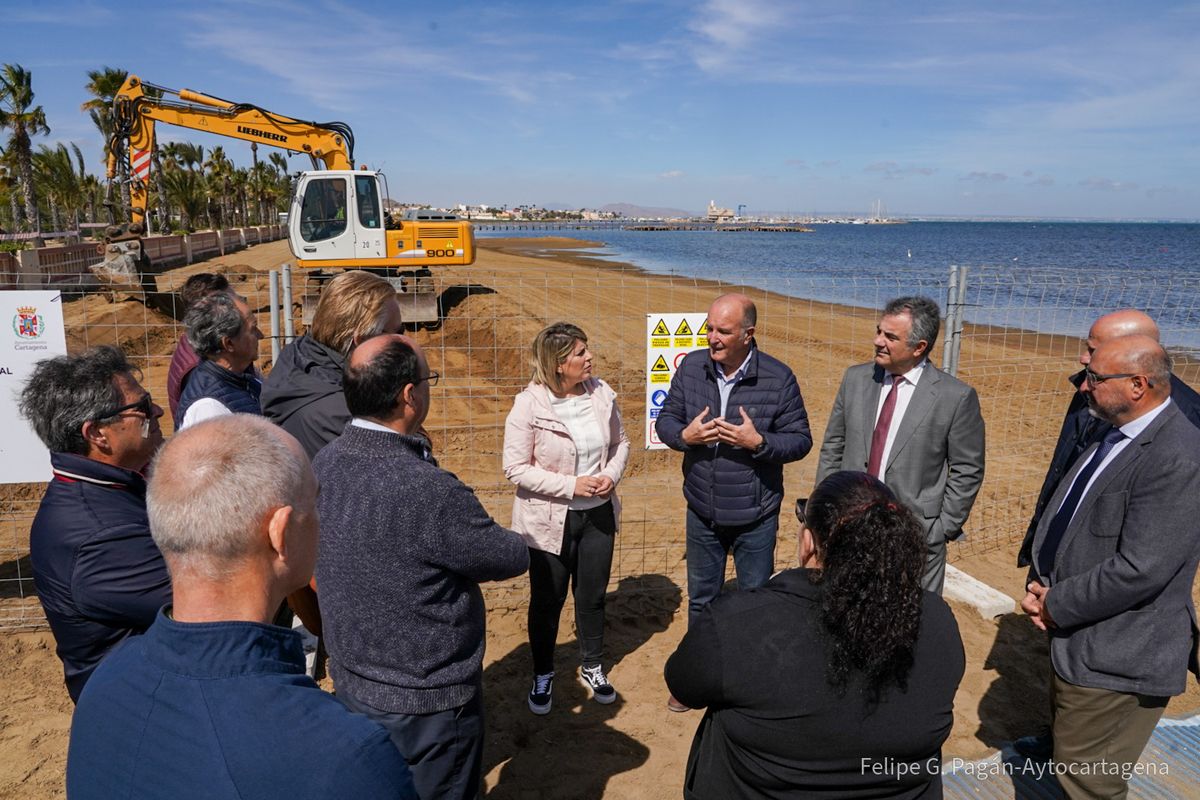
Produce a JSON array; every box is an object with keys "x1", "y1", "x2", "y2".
[{"x1": 0, "y1": 0, "x2": 1200, "y2": 219}]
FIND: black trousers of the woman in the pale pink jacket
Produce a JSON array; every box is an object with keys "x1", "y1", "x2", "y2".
[{"x1": 529, "y1": 503, "x2": 617, "y2": 675}]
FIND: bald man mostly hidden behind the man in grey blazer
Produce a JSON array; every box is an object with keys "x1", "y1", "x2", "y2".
[{"x1": 1016, "y1": 308, "x2": 1200, "y2": 566}]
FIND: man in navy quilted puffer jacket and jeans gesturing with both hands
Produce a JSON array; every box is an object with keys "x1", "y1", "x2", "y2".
[{"x1": 655, "y1": 294, "x2": 812, "y2": 621}]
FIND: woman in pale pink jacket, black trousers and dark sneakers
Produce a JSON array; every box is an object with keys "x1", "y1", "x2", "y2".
[{"x1": 504, "y1": 323, "x2": 629, "y2": 714}]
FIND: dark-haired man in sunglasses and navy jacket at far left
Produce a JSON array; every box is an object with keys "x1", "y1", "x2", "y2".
[{"x1": 20, "y1": 347, "x2": 170, "y2": 702}]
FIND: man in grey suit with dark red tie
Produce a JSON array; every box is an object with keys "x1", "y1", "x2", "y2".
[{"x1": 817, "y1": 296, "x2": 984, "y2": 594}]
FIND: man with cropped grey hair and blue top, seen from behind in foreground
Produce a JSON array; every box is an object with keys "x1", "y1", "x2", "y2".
[{"x1": 66, "y1": 414, "x2": 415, "y2": 800}]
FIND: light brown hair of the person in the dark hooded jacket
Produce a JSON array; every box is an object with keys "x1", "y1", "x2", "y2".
[{"x1": 308, "y1": 270, "x2": 396, "y2": 355}]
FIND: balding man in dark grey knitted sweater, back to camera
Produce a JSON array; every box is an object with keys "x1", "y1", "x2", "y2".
[{"x1": 313, "y1": 335, "x2": 529, "y2": 800}]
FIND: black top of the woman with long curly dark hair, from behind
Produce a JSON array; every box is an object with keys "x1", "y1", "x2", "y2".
[{"x1": 666, "y1": 570, "x2": 966, "y2": 800}]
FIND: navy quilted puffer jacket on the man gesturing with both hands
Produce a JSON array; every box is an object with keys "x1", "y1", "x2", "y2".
[{"x1": 655, "y1": 347, "x2": 812, "y2": 525}]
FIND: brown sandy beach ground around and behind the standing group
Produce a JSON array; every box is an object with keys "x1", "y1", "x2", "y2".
[{"x1": 0, "y1": 237, "x2": 1200, "y2": 799}]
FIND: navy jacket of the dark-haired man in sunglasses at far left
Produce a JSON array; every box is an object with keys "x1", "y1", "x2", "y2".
[{"x1": 29, "y1": 453, "x2": 170, "y2": 700}]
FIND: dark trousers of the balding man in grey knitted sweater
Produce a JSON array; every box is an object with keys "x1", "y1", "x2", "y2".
[{"x1": 337, "y1": 691, "x2": 484, "y2": 800}]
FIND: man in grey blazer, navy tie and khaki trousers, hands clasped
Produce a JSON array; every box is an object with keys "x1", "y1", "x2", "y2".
[{"x1": 1021, "y1": 336, "x2": 1200, "y2": 798}]
